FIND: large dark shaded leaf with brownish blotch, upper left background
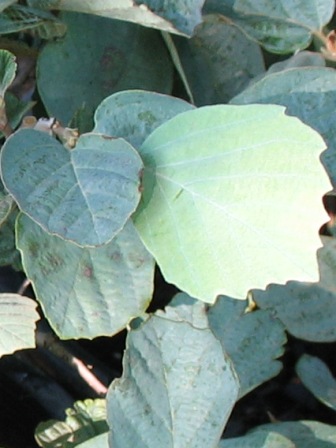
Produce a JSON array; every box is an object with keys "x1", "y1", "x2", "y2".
[{"x1": 37, "y1": 13, "x2": 173, "y2": 123}]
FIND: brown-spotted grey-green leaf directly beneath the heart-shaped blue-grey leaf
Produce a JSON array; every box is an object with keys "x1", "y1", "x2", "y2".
[{"x1": 17, "y1": 215, "x2": 154, "y2": 339}]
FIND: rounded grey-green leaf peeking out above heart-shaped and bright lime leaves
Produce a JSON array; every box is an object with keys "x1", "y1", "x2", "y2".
[{"x1": 93, "y1": 90, "x2": 194, "y2": 148}]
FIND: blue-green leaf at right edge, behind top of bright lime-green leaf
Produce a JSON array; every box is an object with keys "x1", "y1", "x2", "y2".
[{"x1": 231, "y1": 67, "x2": 336, "y2": 186}]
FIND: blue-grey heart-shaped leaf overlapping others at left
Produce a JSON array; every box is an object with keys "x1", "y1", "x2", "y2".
[{"x1": 1, "y1": 129, "x2": 142, "y2": 246}]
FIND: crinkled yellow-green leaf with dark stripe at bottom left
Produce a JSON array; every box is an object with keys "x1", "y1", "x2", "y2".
[{"x1": 35, "y1": 399, "x2": 108, "y2": 448}]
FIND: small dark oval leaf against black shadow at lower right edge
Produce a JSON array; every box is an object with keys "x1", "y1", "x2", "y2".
[{"x1": 295, "y1": 355, "x2": 336, "y2": 411}]
